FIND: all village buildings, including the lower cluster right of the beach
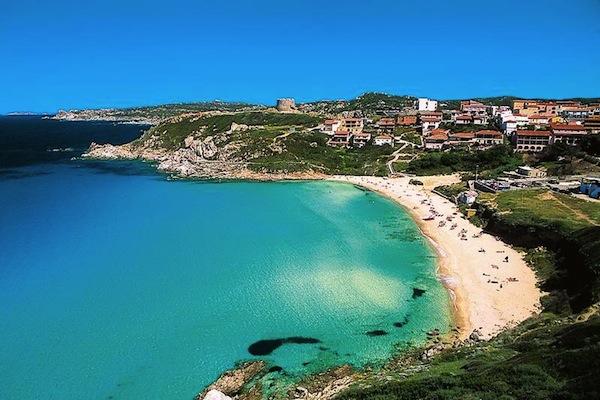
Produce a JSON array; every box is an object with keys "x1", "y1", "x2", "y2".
[{"x1": 294, "y1": 98, "x2": 600, "y2": 204}]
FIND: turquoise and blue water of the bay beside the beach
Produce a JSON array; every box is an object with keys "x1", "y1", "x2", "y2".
[{"x1": 0, "y1": 163, "x2": 450, "y2": 400}]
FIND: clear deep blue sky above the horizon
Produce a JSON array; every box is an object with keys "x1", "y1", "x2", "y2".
[{"x1": 0, "y1": 0, "x2": 600, "y2": 113}]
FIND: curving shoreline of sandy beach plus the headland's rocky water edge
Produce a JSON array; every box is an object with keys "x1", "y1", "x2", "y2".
[{"x1": 81, "y1": 144, "x2": 542, "y2": 341}]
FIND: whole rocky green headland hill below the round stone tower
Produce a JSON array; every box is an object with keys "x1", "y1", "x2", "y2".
[{"x1": 87, "y1": 112, "x2": 393, "y2": 178}]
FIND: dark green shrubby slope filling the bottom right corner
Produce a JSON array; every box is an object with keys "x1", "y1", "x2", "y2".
[{"x1": 338, "y1": 314, "x2": 600, "y2": 400}]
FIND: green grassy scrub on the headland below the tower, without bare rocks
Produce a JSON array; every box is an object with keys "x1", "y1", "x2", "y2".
[{"x1": 138, "y1": 112, "x2": 393, "y2": 175}]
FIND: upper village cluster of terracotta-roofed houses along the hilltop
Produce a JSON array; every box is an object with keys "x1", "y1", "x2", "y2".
[{"x1": 312, "y1": 98, "x2": 600, "y2": 152}]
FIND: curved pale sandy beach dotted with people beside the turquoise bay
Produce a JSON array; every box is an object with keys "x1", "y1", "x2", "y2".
[{"x1": 331, "y1": 176, "x2": 542, "y2": 339}]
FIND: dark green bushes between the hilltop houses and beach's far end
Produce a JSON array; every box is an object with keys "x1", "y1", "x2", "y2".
[{"x1": 406, "y1": 145, "x2": 523, "y2": 177}]
